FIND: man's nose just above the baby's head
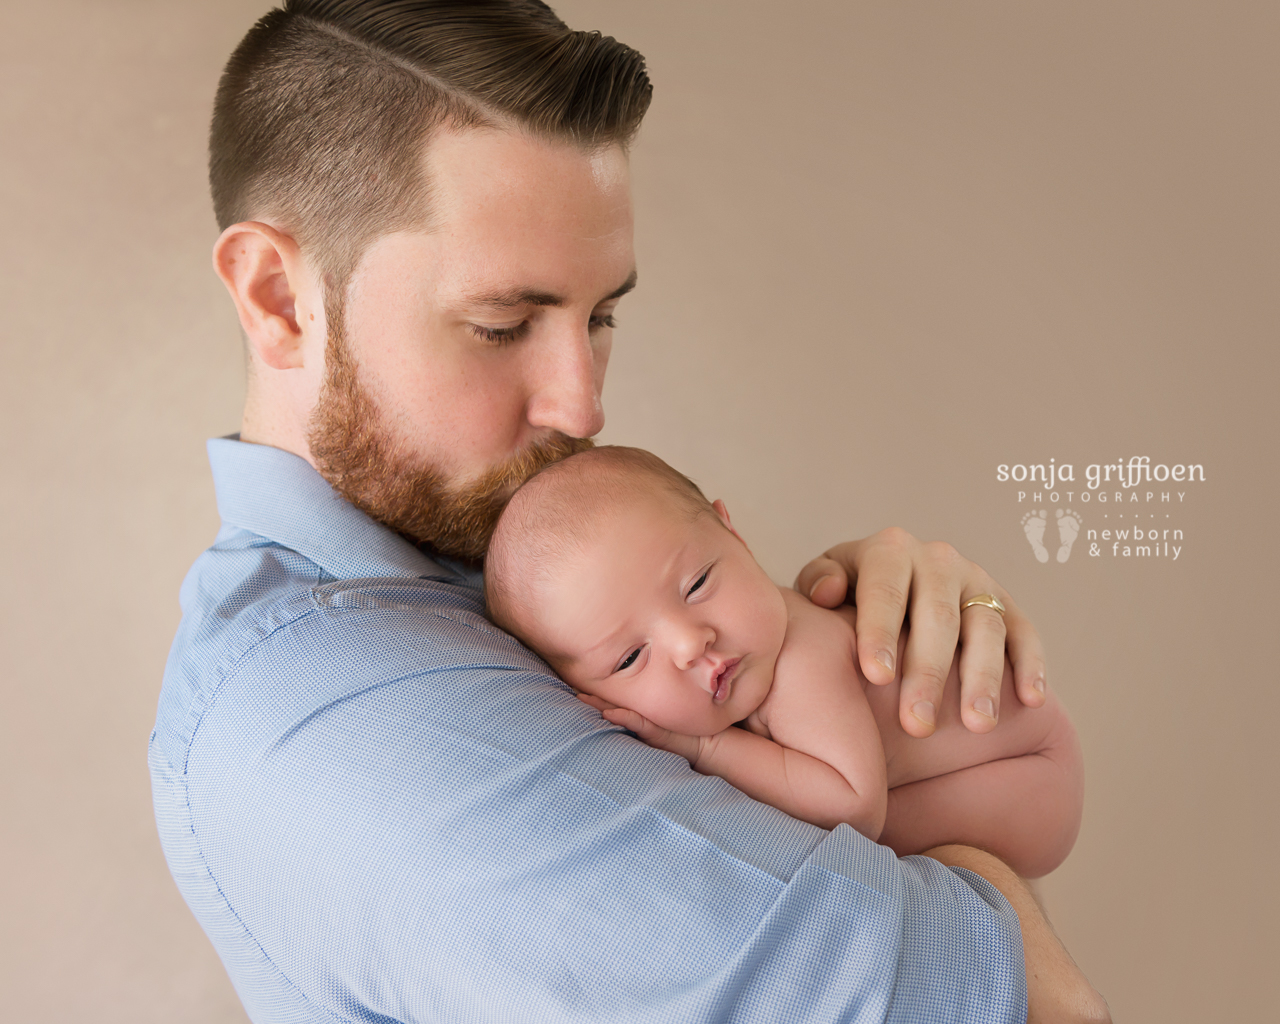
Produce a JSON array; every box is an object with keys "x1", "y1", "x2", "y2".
[{"x1": 526, "y1": 325, "x2": 608, "y2": 438}]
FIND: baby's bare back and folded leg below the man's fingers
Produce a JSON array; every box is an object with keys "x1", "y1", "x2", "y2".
[{"x1": 864, "y1": 657, "x2": 1084, "y2": 878}]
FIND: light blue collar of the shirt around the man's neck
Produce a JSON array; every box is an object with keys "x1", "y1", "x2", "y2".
[{"x1": 209, "y1": 435, "x2": 480, "y2": 586}]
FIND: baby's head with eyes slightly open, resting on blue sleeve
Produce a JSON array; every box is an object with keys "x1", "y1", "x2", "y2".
[{"x1": 485, "y1": 447, "x2": 787, "y2": 736}]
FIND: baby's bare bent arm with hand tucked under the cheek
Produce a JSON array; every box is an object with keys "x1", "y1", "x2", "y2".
[{"x1": 581, "y1": 591, "x2": 888, "y2": 840}]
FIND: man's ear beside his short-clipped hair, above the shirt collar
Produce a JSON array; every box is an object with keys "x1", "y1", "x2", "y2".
[{"x1": 214, "y1": 220, "x2": 323, "y2": 370}]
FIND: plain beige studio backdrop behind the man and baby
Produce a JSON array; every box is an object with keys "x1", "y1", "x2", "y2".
[{"x1": 0, "y1": 0, "x2": 1280, "y2": 1024}]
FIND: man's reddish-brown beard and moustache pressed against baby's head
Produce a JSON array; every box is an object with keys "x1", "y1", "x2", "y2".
[{"x1": 307, "y1": 326, "x2": 593, "y2": 562}]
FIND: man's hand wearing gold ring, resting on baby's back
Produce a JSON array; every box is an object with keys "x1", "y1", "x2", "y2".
[{"x1": 795, "y1": 527, "x2": 1044, "y2": 737}]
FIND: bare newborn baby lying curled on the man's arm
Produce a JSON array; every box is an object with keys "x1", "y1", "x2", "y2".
[{"x1": 485, "y1": 447, "x2": 1083, "y2": 877}]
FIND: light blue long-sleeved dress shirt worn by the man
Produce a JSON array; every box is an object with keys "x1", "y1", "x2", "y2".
[{"x1": 150, "y1": 440, "x2": 1027, "y2": 1024}]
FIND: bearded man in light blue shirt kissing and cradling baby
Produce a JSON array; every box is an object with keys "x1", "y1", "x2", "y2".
[{"x1": 151, "y1": 0, "x2": 1105, "y2": 1021}]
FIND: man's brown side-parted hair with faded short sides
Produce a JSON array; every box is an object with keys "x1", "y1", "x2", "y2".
[{"x1": 209, "y1": 0, "x2": 653, "y2": 302}]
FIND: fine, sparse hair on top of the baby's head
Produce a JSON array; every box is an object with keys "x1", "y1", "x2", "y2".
[{"x1": 484, "y1": 444, "x2": 714, "y2": 636}]
